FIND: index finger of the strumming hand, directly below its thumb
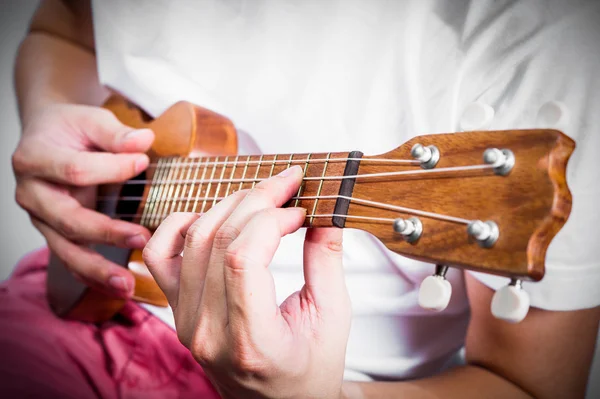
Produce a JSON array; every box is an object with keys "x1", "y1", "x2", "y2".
[{"x1": 20, "y1": 146, "x2": 150, "y2": 186}]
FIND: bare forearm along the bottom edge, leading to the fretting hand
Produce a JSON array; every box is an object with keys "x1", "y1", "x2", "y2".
[{"x1": 342, "y1": 366, "x2": 532, "y2": 399}]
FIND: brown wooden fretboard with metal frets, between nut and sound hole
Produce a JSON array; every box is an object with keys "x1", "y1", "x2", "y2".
[{"x1": 133, "y1": 152, "x2": 362, "y2": 230}]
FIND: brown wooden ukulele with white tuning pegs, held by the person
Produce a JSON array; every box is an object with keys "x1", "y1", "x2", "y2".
[{"x1": 47, "y1": 96, "x2": 575, "y2": 322}]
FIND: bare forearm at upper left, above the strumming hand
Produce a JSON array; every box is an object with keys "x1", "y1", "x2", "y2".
[{"x1": 15, "y1": 1, "x2": 108, "y2": 123}]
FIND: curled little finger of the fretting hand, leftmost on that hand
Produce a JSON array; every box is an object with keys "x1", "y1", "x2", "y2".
[{"x1": 143, "y1": 212, "x2": 200, "y2": 309}]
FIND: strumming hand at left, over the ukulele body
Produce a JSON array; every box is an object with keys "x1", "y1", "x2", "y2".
[{"x1": 12, "y1": 104, "x2": 154, "y2": 298}]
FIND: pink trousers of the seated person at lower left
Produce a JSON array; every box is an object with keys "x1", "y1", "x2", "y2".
[{"x1": 0, "y1": 249, "x2": 218, "y2": 399}]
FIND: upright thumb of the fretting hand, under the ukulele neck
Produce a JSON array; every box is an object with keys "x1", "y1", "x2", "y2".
[{"x1": 304, "y1": 228, "x2": 348, "y2": 308}]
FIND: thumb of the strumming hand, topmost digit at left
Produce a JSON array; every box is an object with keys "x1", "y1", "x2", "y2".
[{"x1": 79, "y1": 108, "x2": 154, "y2": 153}]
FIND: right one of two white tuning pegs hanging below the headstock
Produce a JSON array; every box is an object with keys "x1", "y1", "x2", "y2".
[{"x1": 492, "y1": 279, "x2": 529, "y2": 323}]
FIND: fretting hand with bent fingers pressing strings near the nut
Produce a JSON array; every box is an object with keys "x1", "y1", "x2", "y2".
[{"x1": 144, "y1": 167, "x2": 351, "y2": 398}]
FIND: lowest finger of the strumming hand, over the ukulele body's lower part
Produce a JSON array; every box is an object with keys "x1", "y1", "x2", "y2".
[{"x1": 31, "y1": 218, "x2": 135, "y2": 298}]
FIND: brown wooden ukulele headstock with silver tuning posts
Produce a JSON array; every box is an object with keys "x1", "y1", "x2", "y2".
[{"x1": 345, "y1": 130, "x2": 575, "y2": 281}]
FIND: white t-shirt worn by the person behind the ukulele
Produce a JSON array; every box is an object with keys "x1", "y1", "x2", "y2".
[{"x1": 93, "y1": 0, "x2": 600, "y2": 379}]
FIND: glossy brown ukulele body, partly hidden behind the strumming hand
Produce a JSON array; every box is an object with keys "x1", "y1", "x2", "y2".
[{"x1": 46, "y1": 96, "x2": 237, "y2": 323}]
